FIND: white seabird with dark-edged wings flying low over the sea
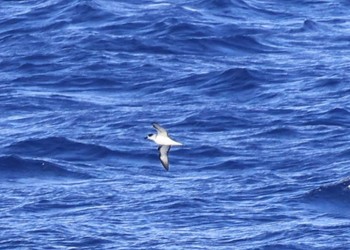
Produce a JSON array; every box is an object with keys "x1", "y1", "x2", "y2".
[{"x1": 145, "y1": 123, "x2": 182, "y2": 171}]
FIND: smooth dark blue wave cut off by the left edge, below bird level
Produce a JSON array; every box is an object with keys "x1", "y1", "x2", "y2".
[{"x1": 0, "y1": 155, "x2": 91, "y2": 179}]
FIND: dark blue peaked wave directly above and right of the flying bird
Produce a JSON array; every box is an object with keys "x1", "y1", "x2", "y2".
[{"x1": 136, "y1": 68, "x2": 266, "y2": 99}]
